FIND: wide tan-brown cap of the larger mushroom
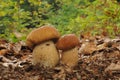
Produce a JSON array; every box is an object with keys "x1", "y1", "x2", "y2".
[{"x1": 26, "y1": 26, "x2": 60, "y2": 47}]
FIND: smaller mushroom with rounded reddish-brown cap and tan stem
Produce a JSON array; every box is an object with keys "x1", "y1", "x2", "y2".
[{"x1": 56, "y1": 34, "x2": 79, "y2": 67}]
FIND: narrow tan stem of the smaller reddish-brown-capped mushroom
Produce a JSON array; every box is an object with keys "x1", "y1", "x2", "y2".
[{"x1": 61, "y1": 47, "x2": 78, "y2": 67}]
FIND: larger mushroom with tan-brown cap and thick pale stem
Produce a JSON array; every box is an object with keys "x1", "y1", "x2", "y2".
[{"x1": 26, "y1": 26, "x2": 60, "y2": 68}]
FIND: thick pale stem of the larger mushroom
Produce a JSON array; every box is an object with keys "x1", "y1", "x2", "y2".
[{"x1": 33, "y1": 41, "x2": 59, "y2": 68}]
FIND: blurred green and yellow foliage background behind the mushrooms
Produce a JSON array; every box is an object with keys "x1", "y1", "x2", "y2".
[{"x1": 0, "y1": 0, "x2": 120, "y2": 42}]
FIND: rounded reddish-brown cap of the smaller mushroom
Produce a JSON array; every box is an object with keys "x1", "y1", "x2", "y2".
[{"x1": 56, "y1": 34, "x2": 79, "y2": 50}]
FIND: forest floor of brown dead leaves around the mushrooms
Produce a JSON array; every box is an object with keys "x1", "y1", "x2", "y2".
[{"x1": 0, "y1": 36, "x2": 120, "y2": 80}]
